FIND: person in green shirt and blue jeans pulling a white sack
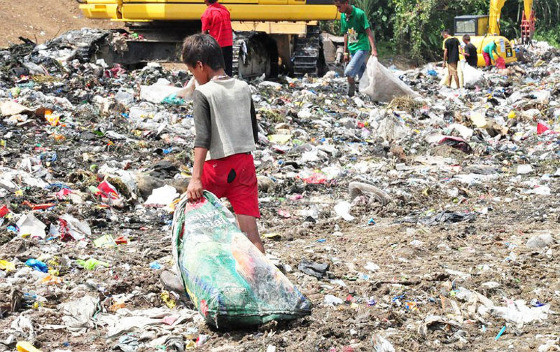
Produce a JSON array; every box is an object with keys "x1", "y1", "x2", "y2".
[{"x1": 334, "y1": 0, "x2": 377, "y2": 96}]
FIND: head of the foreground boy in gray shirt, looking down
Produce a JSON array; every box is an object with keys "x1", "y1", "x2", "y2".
[{"x1": 181, "y1": 33, "x2": 225, "y2": 84}]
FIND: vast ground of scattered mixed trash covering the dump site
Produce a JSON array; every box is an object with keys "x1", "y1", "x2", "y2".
[{"x1": 0, "y1": 29, "x2": 560, "y2": 352}]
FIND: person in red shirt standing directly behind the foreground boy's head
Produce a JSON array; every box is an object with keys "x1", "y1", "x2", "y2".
[{"x1": 200, "y1": 0, "x2": 233, "y2": 76}]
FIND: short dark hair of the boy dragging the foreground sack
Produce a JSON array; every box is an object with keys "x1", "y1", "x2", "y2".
[{"x1": 181, "y1": 33, "x2": 226, "y2": 70}]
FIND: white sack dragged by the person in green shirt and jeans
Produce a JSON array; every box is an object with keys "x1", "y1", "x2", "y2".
[{"x1": 360, "y1": 56, "x2": 419, "y2": 102}]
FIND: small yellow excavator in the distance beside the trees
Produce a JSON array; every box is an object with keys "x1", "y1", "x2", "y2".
[{"x1": 454, "y1": 0, "x2": 536, "y2": 67}]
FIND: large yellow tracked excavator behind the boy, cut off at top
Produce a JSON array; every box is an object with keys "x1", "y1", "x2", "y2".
[{"x1": 77, "y1": 0, "x2": 339, "y2": 78}]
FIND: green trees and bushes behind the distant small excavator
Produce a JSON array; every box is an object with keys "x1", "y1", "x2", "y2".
[{"x1": 323, "y1": 0, "x2": 560, "y2": 63}]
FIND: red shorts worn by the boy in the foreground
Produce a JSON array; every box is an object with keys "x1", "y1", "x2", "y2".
[{"x1": 202, "y1": 154, "x2": 261, "y2": 218}]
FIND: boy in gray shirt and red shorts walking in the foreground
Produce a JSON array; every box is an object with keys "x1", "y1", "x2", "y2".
[{"x1": 182, "y1": 34, "x2": 264, "y2": 253}]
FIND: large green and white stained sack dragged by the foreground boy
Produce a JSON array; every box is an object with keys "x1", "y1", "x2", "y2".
[{"x1": 172, "y1": 191, "x2": 311, "y2": 327}]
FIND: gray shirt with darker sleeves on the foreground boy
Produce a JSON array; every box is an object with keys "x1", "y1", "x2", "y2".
[{"x1": 193, "y1": 78, "x2": 258, "y2": 160}]
